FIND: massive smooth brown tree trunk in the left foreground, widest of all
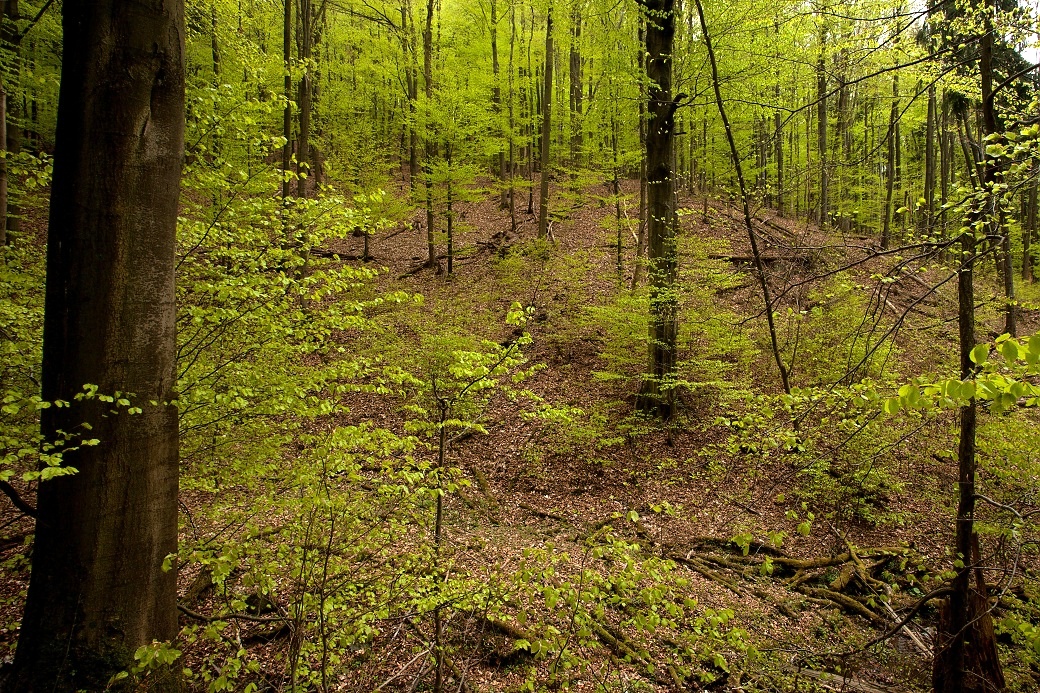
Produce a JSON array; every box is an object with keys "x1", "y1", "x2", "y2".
[{"x1": 5, "y1": 0, "x2": 184, "y2": 691}]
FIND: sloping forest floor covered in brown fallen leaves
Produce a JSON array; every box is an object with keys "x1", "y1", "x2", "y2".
[{"x1": 0, "y1": 184, "x2": 1040, "y2": 693}]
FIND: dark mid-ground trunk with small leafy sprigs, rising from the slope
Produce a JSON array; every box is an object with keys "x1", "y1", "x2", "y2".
[{"x1": 638, "y1": 0, "x2": 679, "y2": 419}]
